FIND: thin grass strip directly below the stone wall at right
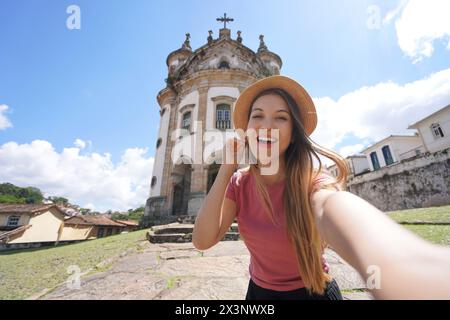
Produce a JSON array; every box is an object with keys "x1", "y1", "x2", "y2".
[{"x1": 387, "y1": 206, "x2": 450, "y2": 223}]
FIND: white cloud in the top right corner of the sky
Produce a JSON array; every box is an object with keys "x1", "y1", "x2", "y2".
[{"x1": 383, "y1": 0, "x2": 450, "y2": 63}]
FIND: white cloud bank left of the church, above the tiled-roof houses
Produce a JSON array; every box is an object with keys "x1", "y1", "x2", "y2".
[{"x1": 0, "y1": 140, "x2": 154, "y2": 211}]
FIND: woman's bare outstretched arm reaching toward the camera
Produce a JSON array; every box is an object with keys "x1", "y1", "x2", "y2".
[{"x1": 312, "y1": 189, "x2": 450, "y2": 299}]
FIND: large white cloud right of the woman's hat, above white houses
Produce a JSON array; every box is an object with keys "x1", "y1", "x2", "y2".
[{"x1": 311, "y1": 69, "x2": 450, "y2": 152}]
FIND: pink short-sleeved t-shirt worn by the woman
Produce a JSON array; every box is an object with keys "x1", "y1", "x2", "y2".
[{"x1": 225, "y1": 170, "x2": 330, "y2": 291}]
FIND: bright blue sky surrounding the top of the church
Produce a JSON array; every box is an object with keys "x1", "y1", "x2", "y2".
[{"x1": 0, "y1": 0, "x2": 450, "y2": 210}]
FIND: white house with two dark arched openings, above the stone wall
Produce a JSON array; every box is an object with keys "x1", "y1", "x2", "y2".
[{"x1": 362, "y1": 134, "x2": 426, "y2": 171}]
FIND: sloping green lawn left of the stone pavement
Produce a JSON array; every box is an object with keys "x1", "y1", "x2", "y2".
[{"x1": 0, "y1": 230, "x2": 147, "y2": 300}]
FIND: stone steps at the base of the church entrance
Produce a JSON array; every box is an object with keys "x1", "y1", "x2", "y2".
[{"x1": 147, "y1": 221, "x2": 240, "y2": 243}]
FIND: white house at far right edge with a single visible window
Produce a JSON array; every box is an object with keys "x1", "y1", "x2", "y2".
[{"x1": 408, "y1": 105, "x2": 450, "y2": 153}]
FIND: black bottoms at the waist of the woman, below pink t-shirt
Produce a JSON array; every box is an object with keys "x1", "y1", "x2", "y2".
[{"x1": 245, "y1": 279, "x2": 343, "y2": 300}]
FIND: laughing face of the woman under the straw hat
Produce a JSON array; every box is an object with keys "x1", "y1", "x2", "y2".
[{"x1": 247, "y1": 93, "x2": 293, "y2": 162}]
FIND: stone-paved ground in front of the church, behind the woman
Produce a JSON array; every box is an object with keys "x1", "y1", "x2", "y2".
[{"x1": 39, "y1": 241, "x2": 372, "y2": 300}]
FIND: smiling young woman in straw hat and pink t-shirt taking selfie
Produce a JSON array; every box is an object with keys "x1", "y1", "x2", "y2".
[{"x1": 192, "y1": 76, "x2": 450, "y2": 300}]
